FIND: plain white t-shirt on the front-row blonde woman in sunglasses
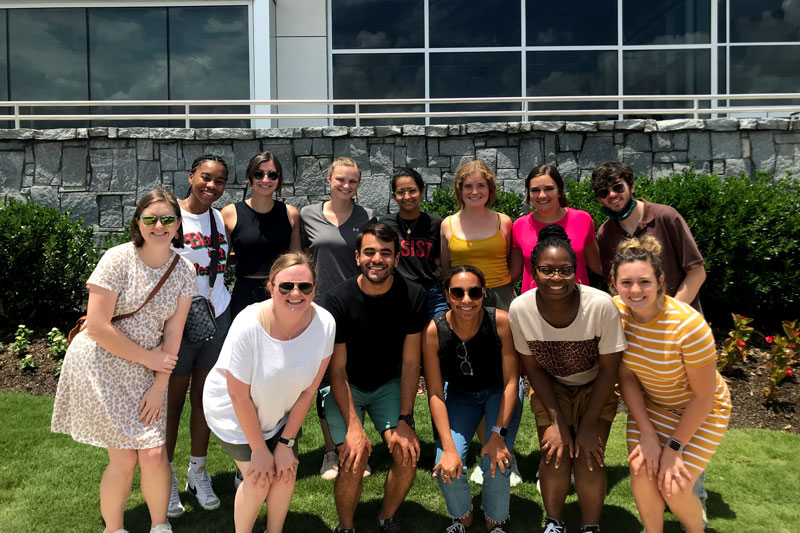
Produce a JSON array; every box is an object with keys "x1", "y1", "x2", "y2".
[{"x1": 203, "y1": 303, "x2": 336, "y2": 444}]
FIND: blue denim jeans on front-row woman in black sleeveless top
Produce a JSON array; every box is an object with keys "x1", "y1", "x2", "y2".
[{"x1": 436, "y1": 384, "x2": 522, "y2": 522}]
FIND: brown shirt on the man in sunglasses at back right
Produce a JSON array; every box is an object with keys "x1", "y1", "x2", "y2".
[{"x1": 597, "y1": 198, "x2": 703, "y2": 313}]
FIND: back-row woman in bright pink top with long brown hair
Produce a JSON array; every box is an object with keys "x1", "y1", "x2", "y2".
[{"x1": 509, "y1": 165, "x2": 602, "y2": 292}]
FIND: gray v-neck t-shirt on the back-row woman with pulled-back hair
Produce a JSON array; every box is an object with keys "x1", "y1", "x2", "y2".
[{"x1": 300, "y1": 202, "x2": 376, "y2": 304}]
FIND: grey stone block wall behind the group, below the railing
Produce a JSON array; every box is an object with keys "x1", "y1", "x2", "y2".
[{"x1": 0, "y1": 118, "x2": 800, "y2": 238}]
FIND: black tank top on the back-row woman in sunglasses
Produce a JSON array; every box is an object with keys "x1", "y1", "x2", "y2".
[{"x1": 231, "y1": 200, "x2": 292, "y2": 277}]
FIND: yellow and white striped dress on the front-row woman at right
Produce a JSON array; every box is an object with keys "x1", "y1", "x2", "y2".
[{"x1": 614, "y1": 296, "x2": 731, "y2": 475}]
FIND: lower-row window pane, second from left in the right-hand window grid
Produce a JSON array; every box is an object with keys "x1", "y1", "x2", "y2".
[{"x1": 429, "y1": 52, "x2": 522, "y2": 124}]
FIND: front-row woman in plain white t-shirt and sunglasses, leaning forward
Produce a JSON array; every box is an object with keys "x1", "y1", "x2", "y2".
[{"x1": 203, "y1": 252, "x2": 336, "y2": 533}]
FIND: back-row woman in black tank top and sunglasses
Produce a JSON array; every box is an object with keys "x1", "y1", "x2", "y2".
[{"x1": 222, "y1": 152, "x2": 300, "y2": 317}]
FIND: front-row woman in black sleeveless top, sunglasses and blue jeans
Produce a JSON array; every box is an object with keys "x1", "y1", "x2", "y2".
[{"x1": 423, "y1": 265, "x2": 522, "y2": 533}]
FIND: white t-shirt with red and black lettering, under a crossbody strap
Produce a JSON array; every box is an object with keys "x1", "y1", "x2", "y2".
[{"x1": 175, "y1": 208, "x2": 231, "y2": 316}]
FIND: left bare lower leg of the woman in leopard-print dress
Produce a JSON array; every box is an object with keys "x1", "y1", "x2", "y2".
[{"x1": 100, "y1": 448, "x2": 137, "y2": 531}]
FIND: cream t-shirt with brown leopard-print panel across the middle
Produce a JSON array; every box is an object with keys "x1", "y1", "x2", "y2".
[{"x1": 508, "y1": 285, "x2": 628, "y2": 385}]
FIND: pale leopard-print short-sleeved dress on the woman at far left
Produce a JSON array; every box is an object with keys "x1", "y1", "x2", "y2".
[{"x1": 51, "y1": 243, "x2": 197, "y2": 450}]
